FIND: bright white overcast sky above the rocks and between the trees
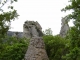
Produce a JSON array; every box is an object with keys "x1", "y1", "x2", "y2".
[{"x1": 3, "y1": 0, "x2": 73, "y2": 35}]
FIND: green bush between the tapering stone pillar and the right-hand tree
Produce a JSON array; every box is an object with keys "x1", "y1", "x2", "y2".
[{"x1": 43, "y1": 35, "x2": 69, "y2": 60}]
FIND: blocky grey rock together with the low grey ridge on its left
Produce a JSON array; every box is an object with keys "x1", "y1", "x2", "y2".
[{"x1": 7, "y1": 21, "x2": 43, "y2": 38}]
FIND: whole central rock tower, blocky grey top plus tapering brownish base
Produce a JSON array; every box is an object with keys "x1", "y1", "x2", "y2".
[{"x1": 23, "y1": 21, "x2": 49, "y2": 60}]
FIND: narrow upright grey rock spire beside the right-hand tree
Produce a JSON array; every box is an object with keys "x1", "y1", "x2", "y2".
[{"x1": 60, "y1": 17, "x2": 69, "y2": 37}]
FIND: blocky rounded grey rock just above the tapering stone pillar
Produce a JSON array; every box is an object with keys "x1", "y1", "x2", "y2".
[{"x1": 23, "y1": 21, "x2": 43, "y2": 38}]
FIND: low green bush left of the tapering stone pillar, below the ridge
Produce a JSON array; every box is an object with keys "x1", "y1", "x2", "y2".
[{"x1": 0, "y1": 37, "x2": 28, "y2": 60}]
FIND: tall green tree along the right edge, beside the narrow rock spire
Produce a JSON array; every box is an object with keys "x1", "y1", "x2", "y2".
[{"x1": 62, "y1": 0, "x2": 80, "y2": 60}]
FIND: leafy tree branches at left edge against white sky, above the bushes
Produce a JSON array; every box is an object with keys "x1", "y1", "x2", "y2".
[{"x1": 0, "y1": 0, "x2": 19, "y2": 40}]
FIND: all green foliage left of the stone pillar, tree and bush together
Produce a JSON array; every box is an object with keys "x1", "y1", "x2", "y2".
[{"x1": 0, "y1": 0, "x2": 28, "y2": 60}]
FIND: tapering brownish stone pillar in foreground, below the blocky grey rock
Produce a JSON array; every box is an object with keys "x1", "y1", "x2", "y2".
[{"x1": 24, "y1": 37, "x2": 49, "y2": 60}]
